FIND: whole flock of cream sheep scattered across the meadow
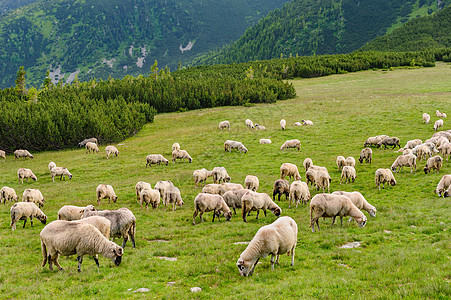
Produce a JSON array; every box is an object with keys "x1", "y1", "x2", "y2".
[{"x1": 0, "y1": 111, "x2": 451, "y2": 276}]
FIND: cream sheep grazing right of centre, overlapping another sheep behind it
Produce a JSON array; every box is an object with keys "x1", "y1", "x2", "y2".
[{"x1": 310, "y1": 194, "x2": 367, "y2": 232}]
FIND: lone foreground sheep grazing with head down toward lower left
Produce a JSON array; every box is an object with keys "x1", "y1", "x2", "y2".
[{"x1": 236, "y1": 217, "x2": 298, "y2": 276}]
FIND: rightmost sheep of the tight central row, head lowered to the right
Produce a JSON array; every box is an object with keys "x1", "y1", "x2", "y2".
[{"x1": 241, "y1": 191, "x2": 282, "y2": 222}]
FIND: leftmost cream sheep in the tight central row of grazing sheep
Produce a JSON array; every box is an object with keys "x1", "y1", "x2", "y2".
[{"x1": 193, "y1": 193, "x2": 232, "y2": 225}]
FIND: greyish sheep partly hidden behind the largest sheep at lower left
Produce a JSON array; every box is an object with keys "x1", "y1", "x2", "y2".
[{"x1": 83, "y1": 207, "x2": 136, "y2": 248}]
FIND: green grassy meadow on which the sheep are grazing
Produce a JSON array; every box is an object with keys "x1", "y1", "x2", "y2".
[{"x1": 0, "y1": 63, "x2": 451, "y2": 299}]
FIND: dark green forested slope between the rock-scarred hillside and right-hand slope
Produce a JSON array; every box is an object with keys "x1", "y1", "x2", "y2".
[{"x1": 195, "y1": 0, "x2": 451, "y2": 64}]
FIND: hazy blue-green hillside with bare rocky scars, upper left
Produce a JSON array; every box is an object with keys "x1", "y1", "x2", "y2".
[{"x1": 0, "y1": 0, "x2": 286, "y2": 88}]
